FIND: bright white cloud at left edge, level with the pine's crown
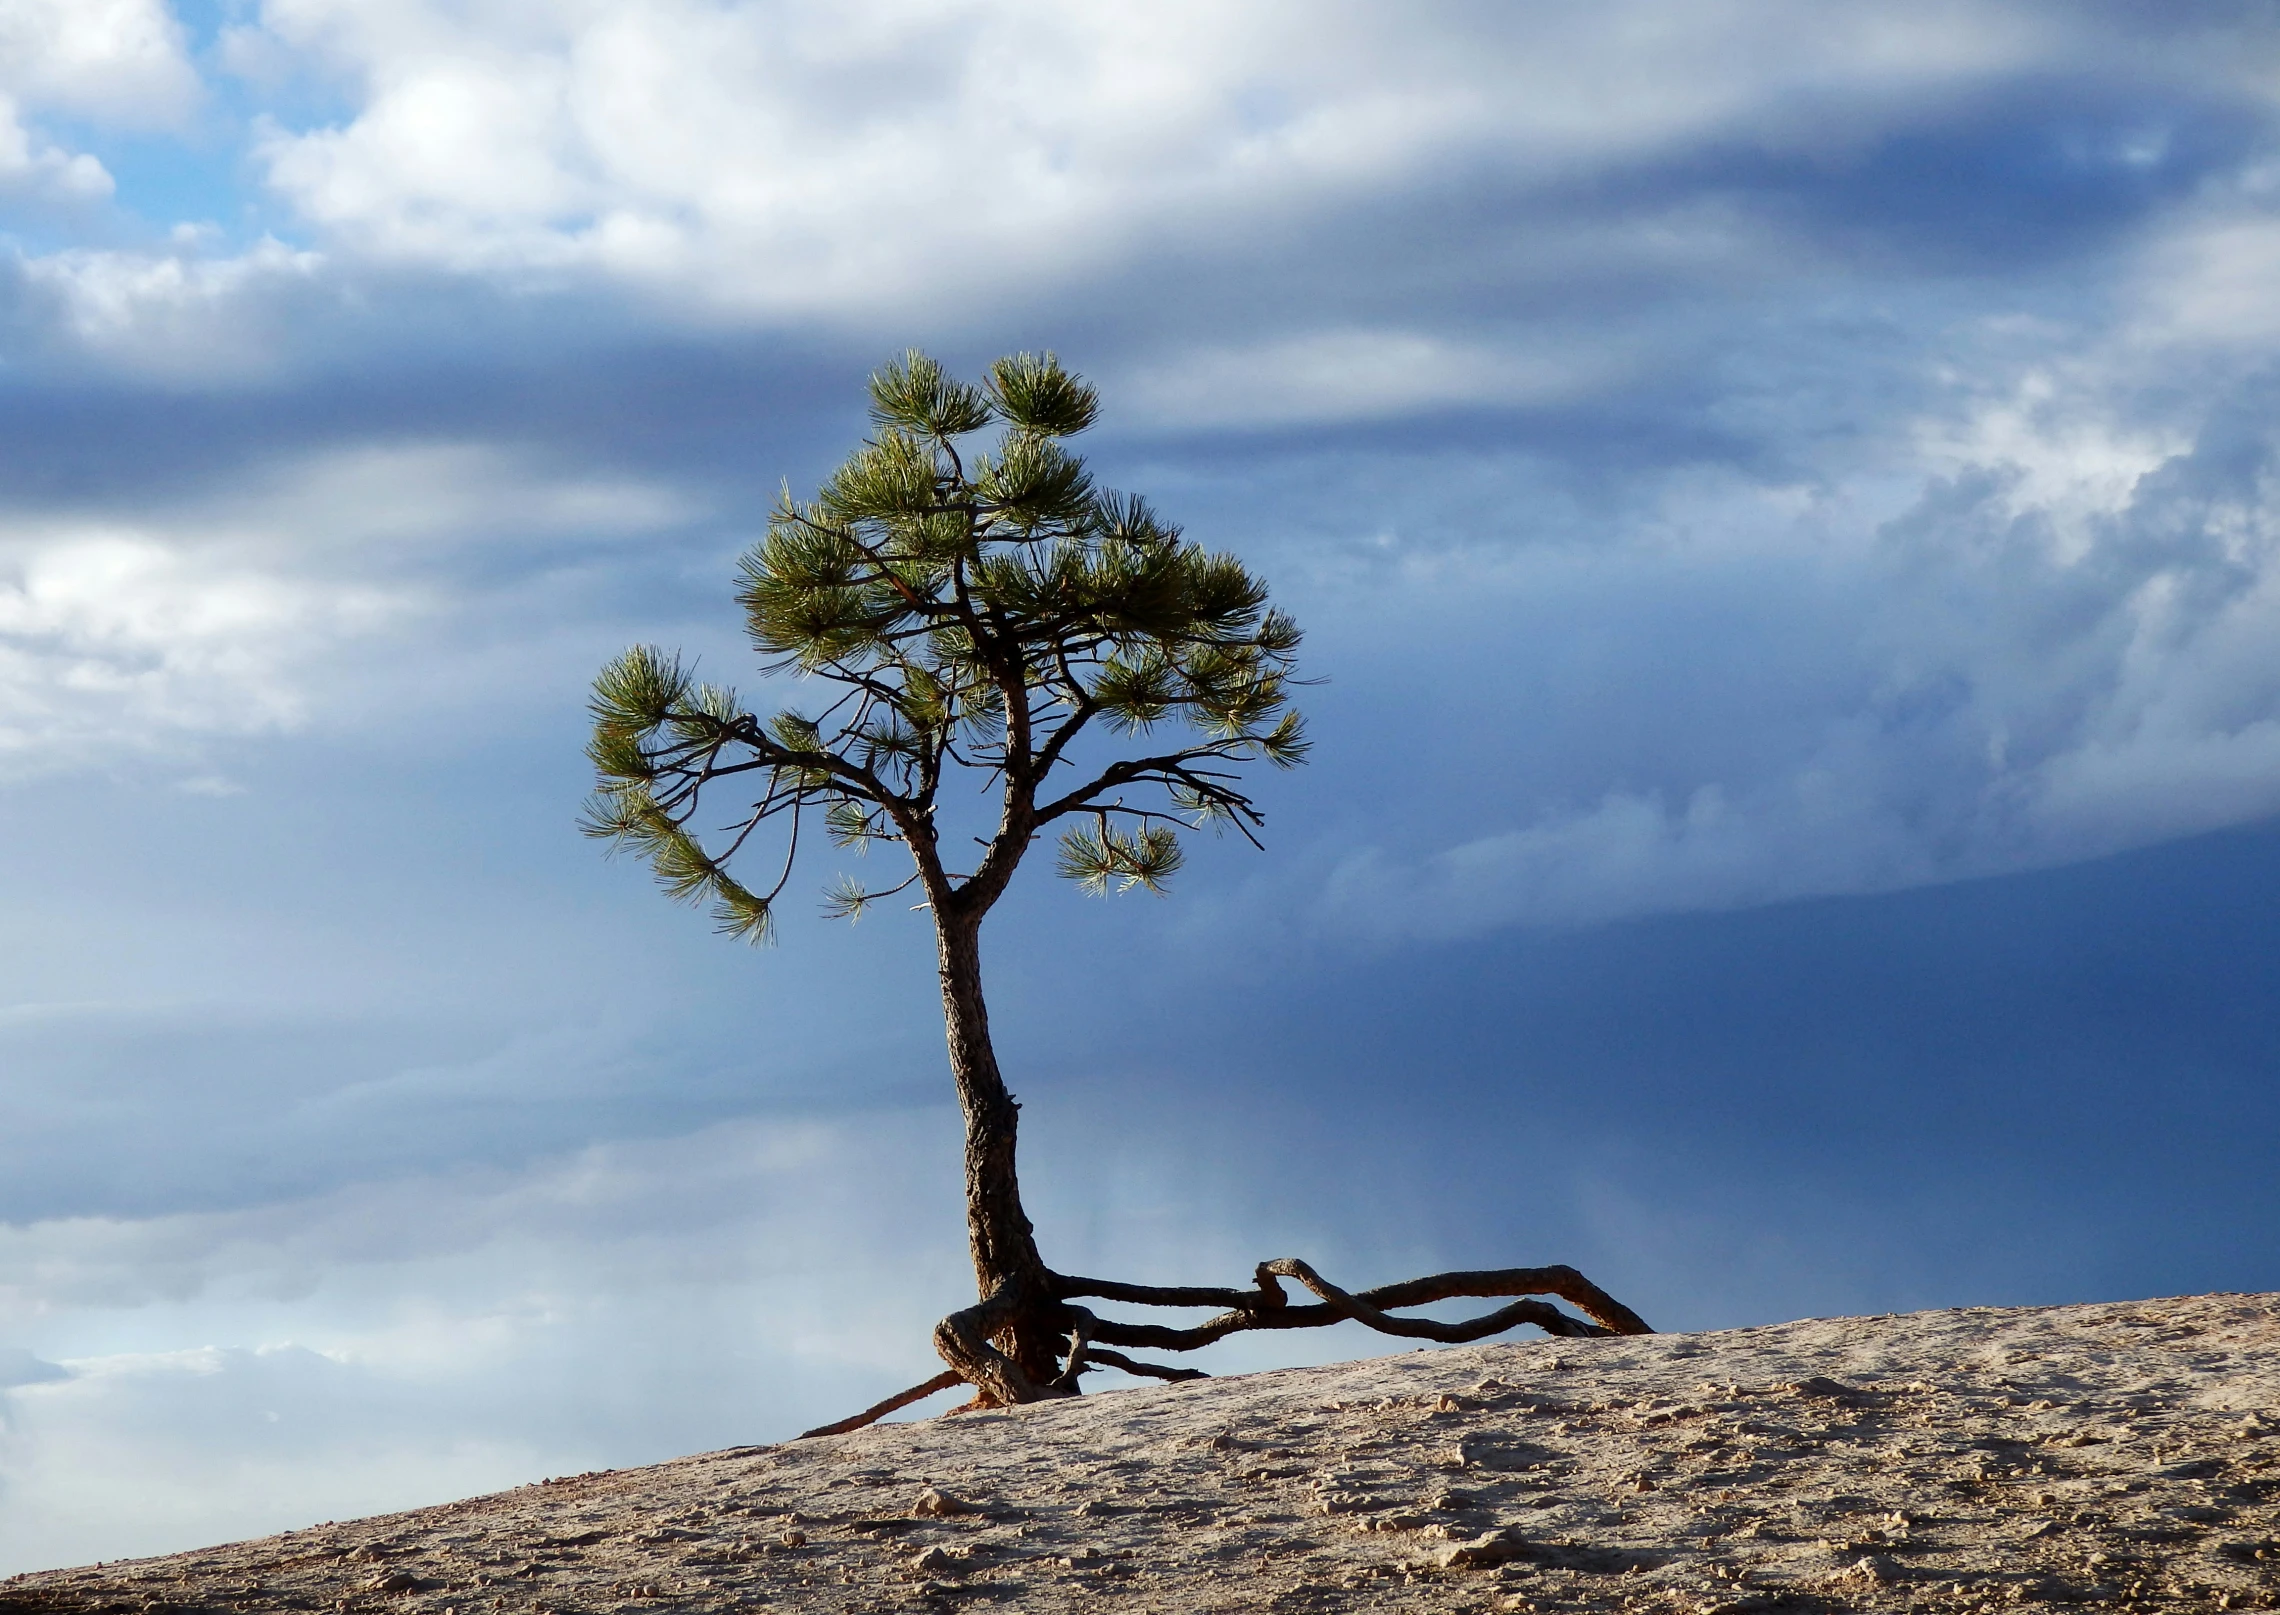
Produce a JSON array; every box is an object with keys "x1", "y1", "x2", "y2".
[{"x1": 0, "y1": 443, "x2": 689, "y2": 789}]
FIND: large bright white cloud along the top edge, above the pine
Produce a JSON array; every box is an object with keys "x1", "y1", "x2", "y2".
[{"x1": 240, "y1": 0, "x2": 2052, "y2": 315}]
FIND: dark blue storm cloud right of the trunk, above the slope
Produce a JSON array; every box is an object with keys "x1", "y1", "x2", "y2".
[{"x1": 1008, "y1": 826, "x2": 2280, "y2": 1328}]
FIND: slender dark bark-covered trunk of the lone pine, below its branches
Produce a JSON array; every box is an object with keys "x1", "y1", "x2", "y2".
[{"x1": 935, "y1": 910, "x2": 1060, "y2": 1385}]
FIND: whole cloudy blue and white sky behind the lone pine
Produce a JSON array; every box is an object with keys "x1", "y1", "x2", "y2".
[{"x1": 0, "y1": 0, "x2": 2280, "y2": 1574}]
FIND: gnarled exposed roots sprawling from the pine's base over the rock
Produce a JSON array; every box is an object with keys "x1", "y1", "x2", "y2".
[{"x1": 800, "y1": 1257, "x2": 1653, "y2": 1439}]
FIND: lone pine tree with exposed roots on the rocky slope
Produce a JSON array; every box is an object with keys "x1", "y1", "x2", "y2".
[{"x1": 584, "y1": 351, "x2": 1646, "y2": 1435}]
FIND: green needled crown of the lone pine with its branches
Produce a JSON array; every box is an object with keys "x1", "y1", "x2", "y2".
[{"x1": 584, "y1": 351, "x2": 1306, "y2": 942}]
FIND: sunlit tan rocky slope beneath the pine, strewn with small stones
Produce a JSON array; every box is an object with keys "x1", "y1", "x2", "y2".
[{"x1": 0, "y1": 1296, "x2": 2280, "y2": 1615}]
